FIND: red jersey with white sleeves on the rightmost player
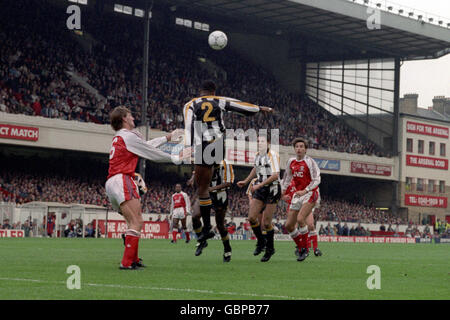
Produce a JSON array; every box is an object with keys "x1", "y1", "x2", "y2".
[{"x1": 282, "y1": 156, "x2": 320, "y2": 196}]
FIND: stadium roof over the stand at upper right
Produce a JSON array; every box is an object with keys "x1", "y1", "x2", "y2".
[{"x1": 149, "y1": 0, "x2": 450, "y2": 61}]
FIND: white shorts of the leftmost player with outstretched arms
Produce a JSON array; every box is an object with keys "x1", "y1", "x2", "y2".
[{"x1": 105, "y1": 173, "x2": 141, "y2": 213}]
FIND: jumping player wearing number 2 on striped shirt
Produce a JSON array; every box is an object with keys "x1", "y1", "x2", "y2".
[{"x1": 183, "y1": 81, "x2": 273, "y2": 252}]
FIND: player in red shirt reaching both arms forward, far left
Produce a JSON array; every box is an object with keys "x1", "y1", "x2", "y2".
[{"x1": 105, "y1": 106, "x2": 186, "y2": 270}]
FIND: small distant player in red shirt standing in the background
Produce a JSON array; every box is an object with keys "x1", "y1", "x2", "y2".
[{"x1": 170, "y1": 183, "x2": 191, "y2": 243}]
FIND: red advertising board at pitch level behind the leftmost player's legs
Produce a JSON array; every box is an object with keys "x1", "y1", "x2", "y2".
[{"x1": 98, "y1": 220, "x2": 169, "y2": 239}]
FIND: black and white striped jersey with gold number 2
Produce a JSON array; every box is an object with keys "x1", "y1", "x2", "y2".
[{"x1": 183, "y1": 96, "x2": 260, "y2": 146}]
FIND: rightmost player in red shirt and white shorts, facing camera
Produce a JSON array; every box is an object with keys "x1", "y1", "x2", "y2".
[{"x1": 282, "y1": 138, "x2": 320, "y2": 261}]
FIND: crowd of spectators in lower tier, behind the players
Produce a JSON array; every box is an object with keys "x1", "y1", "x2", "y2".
[{"x1": 0, "y1": 164, "x2": 407, "y2": 225}]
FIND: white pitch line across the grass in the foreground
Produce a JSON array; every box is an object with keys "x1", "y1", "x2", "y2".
[{"x1": 0, "y1": 278, "x2": 315, "y2": 300}]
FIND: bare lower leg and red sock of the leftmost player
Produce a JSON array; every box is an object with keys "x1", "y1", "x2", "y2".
[{"x1": 120, "y1": 199, "x2": 143, "y2": 270}]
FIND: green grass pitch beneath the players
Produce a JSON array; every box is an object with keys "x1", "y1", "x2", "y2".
[{"x1": 0, "y1": 238, "x2": 450, "y2": 300}]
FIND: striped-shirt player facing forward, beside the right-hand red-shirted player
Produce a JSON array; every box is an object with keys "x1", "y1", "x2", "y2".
[{"x1": 237, "y1": 136, "x2": 281, "y2": 262}]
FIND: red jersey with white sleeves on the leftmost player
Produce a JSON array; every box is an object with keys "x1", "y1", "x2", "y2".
[{"x1": 108, "y1": 129, "x2": 172, "y2": 179}]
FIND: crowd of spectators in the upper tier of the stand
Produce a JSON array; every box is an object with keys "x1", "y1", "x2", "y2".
[{"x1": 0, "y1": 0, "x2": 382, "y2": 155}]
